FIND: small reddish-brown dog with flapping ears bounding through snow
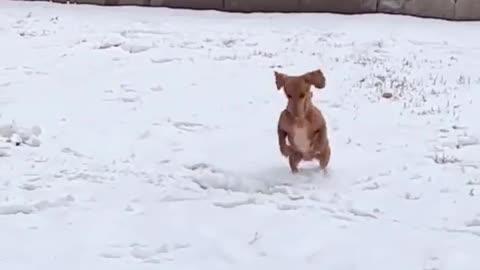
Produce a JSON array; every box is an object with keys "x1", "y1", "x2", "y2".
[{"x1": 274, "y1": 70, "x2": 330, "y2": 173}]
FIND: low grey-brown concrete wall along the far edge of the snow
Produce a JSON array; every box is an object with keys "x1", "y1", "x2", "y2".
[{"x1": 38, "y1": 0, "x2": 480, "y2": 20}]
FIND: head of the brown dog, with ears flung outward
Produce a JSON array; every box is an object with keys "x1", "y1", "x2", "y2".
[{"x1": 274, "y1": 69, "x2": 325, "y2": 119}]
